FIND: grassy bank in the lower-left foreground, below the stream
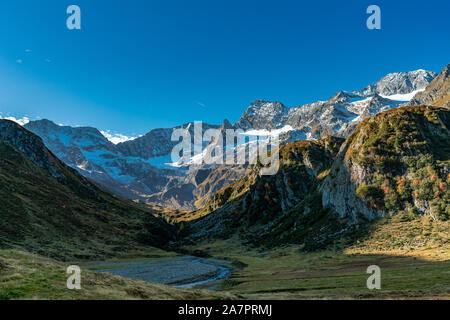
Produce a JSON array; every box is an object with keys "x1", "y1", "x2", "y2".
[{"x1": 0, "y1": 250, "x2": 236, "y2": 300}]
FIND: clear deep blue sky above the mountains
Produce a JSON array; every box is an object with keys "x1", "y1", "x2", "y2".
[{"x1": 0, "y1": 0, "x2": 450, "y2": 135}]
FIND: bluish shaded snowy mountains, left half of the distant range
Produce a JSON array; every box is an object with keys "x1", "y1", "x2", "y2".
[{"x1": 25, "y1": 120, "x2": 243, "y2": 210}]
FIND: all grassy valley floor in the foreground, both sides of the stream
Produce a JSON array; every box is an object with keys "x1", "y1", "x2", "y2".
[{"x1": 0, "y1": 214, "x2": 450, "y2": 300}]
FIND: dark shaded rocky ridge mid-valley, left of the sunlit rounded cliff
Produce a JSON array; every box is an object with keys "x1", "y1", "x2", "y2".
[{"x1": 185, "y1": 137, "x2": 343, "y2": 248}]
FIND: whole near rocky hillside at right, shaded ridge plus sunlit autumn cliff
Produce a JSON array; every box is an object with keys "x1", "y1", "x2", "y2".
[{"x1": 186, "y1": 106, "x2": 450, "y2": 250}]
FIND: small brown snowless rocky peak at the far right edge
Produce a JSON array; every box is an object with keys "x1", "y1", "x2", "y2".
[{"x1": 411, "y1": 64, "x2": 450, "y2": 108}]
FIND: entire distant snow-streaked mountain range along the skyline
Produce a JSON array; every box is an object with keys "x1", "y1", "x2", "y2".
[{"x1": 16, "y1": 70, "x2": 436, "y2": 210}]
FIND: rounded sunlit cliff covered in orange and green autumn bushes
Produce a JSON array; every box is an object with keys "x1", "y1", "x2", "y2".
[{"x1": 321, "y1": 107, "x2": 450, "y2": 221}]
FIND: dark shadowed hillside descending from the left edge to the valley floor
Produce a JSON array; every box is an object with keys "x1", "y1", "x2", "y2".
[{"x1": 0, "y1": 120, "x2": 173, "y2": 260}]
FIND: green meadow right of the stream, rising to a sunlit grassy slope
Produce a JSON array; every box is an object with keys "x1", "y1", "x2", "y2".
[{"x1": 187, "y1": 214, "x2": 450, "y2": 299}]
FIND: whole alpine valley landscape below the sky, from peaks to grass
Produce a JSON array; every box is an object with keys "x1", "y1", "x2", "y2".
[{"x1": 0, "y1": 64, "x2": 450, "y2": 299}]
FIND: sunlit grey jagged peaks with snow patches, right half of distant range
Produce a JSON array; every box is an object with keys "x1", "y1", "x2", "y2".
[{"x1": 235, "y1": 70, "x2": 436, "y2": 142}]
